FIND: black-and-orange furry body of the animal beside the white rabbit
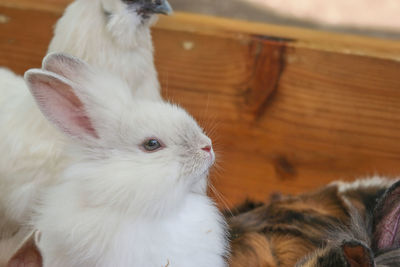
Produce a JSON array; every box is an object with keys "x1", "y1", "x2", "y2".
[{"x1": 226, "y1": 178, "x2": 394, "y2": 267}]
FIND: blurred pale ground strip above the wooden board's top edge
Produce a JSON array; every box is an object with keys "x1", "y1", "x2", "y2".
[{"x1": 170, "y1": 0, "x2": 400, "y2": 40}]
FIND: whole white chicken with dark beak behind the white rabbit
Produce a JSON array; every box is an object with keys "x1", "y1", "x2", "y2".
[{"x1": 0, "y1": 0, "x2": 171, "y2": 239}]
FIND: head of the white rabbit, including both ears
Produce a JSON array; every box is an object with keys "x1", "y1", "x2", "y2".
[{"x1": 25, "y1": 53, "x2": 215, "y2": 219}]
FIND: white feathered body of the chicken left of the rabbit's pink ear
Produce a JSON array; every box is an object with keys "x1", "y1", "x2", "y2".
[{"x1": 0, "y1": 68, "x2": 64, "y2": 232}]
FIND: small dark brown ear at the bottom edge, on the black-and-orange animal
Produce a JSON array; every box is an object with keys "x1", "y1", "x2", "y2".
[{"x1": 342, "y1": 241, "x2": 375, "y2": 267}]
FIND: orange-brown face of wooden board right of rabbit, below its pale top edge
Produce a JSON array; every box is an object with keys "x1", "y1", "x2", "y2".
[{"x1": 154, "y1": 30, "x2": 400, "y2": 206}]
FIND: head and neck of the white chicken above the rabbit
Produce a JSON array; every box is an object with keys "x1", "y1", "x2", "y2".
[{"x1": 49, "y1": 0, "x2": 172, "y2": 100}]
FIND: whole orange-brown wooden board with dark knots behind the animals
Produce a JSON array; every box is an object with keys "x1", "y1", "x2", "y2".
[{"x1": 0, "y1": 0, "x2": 400, "y2": 209}]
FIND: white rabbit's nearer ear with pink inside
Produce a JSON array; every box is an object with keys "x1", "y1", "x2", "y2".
[{"x1": 25, "y1": 70, "x2": 98, "y2": 139}]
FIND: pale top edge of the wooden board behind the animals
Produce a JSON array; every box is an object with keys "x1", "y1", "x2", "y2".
[{"x1": 0, "y1": 0, "x2": 400, "y2": 61}]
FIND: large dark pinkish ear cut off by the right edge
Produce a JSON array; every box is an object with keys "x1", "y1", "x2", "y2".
[{"x1": 372, "y1": 181, "x2": 400, "y2": 250}]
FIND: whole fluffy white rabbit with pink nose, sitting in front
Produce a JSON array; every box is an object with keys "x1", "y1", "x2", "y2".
[{"x1": 25, "y1": 54, "x2": 227, "y2": 267}]
